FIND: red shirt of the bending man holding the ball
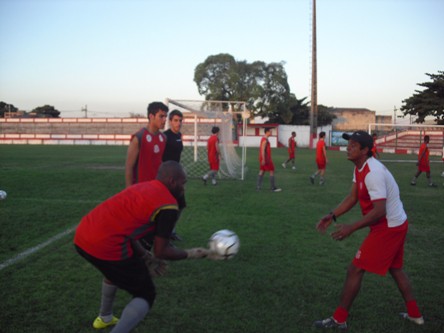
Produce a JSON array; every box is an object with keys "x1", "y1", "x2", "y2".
[{"x1": 74, "y1": 180, "x2": 178, "y2": 260}]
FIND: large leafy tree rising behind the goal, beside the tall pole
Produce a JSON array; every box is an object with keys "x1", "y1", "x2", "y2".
[{"x1": 194, "y1": 53, "x2": 334, "y2": 125}]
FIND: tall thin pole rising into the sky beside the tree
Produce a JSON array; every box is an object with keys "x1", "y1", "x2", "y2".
[{"x1": 310, "y1": 0, "x2": 318, "y2": 148}]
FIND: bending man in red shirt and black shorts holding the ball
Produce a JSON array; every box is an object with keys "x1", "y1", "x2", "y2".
[{"x1": 74, "y1": 161, "x2": 217, "y2": 332}]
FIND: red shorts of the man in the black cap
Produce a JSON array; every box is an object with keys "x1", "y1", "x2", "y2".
[{"x1": 353, "y1": 221, "x2": 408, "y2": 275}]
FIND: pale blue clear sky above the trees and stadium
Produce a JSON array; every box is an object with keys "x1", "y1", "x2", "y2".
[{"x1": 0, "y1": 0, "x2": 444, "y2": 117}]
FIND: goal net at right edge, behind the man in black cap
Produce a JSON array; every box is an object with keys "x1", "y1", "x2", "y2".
[{"x1": 368, "y1": 123, "x2": 444, "y2": 156}]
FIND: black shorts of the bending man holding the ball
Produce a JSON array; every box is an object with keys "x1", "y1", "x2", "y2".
[{"x1": 74, "y1": 245, "x2": 156, "y2": 308}]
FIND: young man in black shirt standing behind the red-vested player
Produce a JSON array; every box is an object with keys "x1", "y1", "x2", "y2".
[{"x1": 162, "y1": 110, "x2": 187, "y2": 241}]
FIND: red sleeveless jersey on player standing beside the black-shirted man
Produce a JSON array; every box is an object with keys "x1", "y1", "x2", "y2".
[{"x1": 131, "y1": 128, "x2": 166, "y2": 184}]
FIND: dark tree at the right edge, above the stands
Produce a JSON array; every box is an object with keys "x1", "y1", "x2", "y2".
[{"x1": 401, "y1": 71, "x2": 444, "y2": 125}]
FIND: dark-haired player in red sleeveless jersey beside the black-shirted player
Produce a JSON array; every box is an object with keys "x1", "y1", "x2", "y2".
[{"x1": 125, "y1": 102, "x2": 168, "y2": 187}]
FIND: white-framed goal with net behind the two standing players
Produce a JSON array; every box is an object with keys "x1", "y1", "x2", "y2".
[{"x1": 166, "y1": 99, "x2": 247, "y2": 180}]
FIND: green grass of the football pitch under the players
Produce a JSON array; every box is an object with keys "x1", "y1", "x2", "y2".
[{"x1": 0, "y1": 145, "x2": 444, "y2": 333}]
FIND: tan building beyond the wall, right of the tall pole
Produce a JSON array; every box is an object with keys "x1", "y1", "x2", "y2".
[{"x1": 331, "y1": 108, "x2": 392, "y2": 132}]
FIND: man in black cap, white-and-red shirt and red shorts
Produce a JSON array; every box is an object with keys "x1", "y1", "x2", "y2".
[{"x1": 314, "y1": 131, "x2": 424, "y2": 329}]
